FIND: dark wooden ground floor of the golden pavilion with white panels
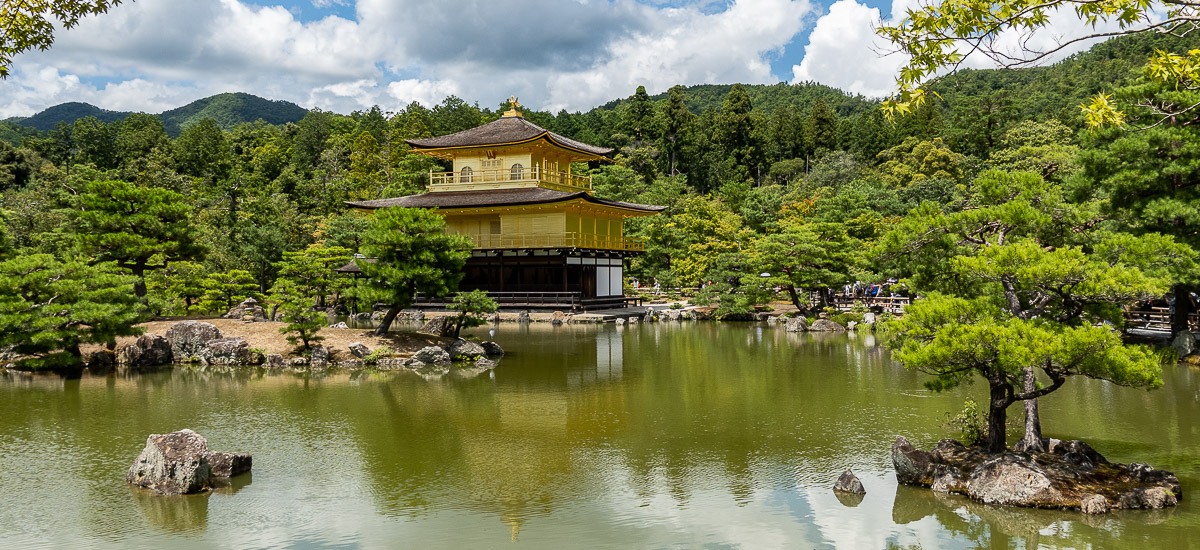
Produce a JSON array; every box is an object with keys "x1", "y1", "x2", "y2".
[{"x1": 418, "y1": 250, "x2": 636, "y2": 311}]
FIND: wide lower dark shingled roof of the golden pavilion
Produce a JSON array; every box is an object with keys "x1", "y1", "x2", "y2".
[{"x1": 346, "y1": 187, "x2": 666, "y2": 213}]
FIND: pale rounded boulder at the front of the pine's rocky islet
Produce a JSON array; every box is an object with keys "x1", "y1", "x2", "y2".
[{"x1": 967, "y1": 453, "x2": 1063, "y2": 507}]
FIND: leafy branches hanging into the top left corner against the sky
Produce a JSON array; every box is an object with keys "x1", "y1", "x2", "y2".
[{"x1": 0, "y1": 0, "x2": 121, "y2": 78}]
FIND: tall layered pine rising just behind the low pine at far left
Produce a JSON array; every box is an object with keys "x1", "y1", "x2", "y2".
[{"x1": 74, "y1": 180, "x2": 202, "y2": 298}]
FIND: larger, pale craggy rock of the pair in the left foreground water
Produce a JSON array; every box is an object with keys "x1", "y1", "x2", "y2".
[{"x1": 125, "y1": 430, "x2": 212, "y2": 495}]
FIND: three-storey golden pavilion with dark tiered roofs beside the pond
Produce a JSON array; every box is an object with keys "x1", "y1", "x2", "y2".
[{"x1": 347, "y1": 97, "x2": 666, "y2": 310}]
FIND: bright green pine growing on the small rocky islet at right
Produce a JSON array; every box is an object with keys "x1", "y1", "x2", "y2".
[{"x1": 880, "y1": 172, "x2": 1194, "y2": 452}]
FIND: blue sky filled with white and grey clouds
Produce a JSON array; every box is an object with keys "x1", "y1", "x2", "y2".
[{"x1": 0, "y1": 0, "x2": 1123, "y2": 119}]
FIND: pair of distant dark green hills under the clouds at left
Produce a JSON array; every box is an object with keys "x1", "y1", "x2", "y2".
[{"x1": 5, "y1": 92, "x2": 308, "y2": 137}]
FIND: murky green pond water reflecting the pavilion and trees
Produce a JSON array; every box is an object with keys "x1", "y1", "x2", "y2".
[{"x1": 0, "y1": 323, "x2": 1200, "y2": 549}]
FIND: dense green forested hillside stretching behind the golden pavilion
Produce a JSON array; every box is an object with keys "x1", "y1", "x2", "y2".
[{"x1": 0, "y1": 31, "x2": 1200, "y2": 365}]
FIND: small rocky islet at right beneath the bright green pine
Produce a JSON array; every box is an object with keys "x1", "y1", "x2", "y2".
[{"x1": 892, "y1": 436, "x2": 1183, "y2": 514}]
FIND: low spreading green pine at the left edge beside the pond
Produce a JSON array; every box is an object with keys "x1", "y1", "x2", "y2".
[{"x1": 0, "y1": 253, "x2": 142, "y2": 370}]
